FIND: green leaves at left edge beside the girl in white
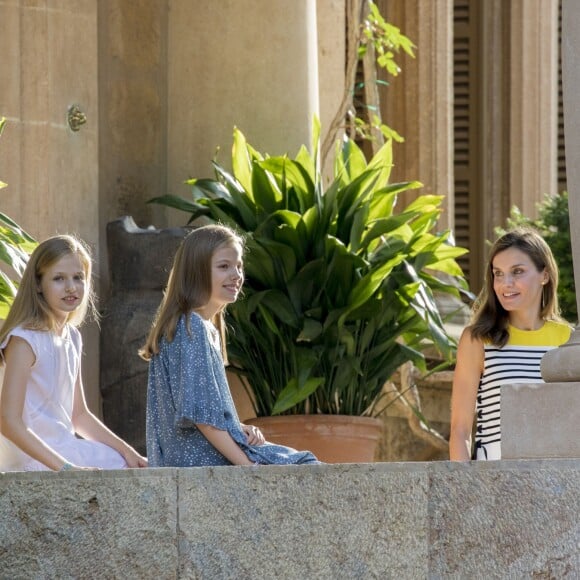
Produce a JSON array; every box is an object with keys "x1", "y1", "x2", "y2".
[{"x1": 0, "y1": 117, "x2": 36, "y2": 319}]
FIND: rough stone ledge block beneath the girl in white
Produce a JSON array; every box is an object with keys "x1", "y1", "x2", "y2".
[{"x1": 0, "y1": 469, "x2": 178, "y2": 579}]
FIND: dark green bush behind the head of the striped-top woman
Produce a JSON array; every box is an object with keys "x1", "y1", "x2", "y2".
[{"x1": 496, "y1": 191, "x2": 578, "y2": 323}]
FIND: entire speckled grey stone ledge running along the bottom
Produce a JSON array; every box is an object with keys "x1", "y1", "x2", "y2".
[{"x1": 0, "y1": 460, "x2": 580, "y2": 579}]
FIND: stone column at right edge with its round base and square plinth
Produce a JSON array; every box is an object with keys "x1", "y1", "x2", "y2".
[{"x1": 501, "y1": 0, "x2": 580, "y2": 459}]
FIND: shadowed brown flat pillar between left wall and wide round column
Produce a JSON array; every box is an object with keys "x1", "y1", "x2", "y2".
[{"x1": 98, "y1": 0, "x2": 168, "y2": 238}]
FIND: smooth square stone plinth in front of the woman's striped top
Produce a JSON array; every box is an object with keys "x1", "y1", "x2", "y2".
[{"x1": 501, "y1": 382, "x2": 580, "y2": 459}]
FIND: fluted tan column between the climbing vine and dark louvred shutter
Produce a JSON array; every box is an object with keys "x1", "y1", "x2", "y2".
[{"x1": 377, "y1": 0, "x2": 454, "y2": 228}]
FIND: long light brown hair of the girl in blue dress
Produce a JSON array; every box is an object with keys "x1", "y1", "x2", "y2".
[{"x1": 139, "y1": 225, "x2": 244, "y2": 361}]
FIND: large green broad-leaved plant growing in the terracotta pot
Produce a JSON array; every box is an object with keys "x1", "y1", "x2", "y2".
[{"x1": 151, "y1": 123, "x2": 467, "y2": 416}]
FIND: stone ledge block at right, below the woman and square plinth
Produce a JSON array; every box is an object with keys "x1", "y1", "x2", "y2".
[{"x1": 428, "y1": 460, "x2": 580, "y2": 579}]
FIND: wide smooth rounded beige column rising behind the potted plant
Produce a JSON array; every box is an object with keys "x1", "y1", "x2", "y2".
[{"x1": 167, "y1": 0, "x2": 319, "y2": 204}]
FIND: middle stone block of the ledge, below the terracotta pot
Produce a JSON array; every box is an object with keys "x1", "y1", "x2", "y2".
[{"x1": 179, "y1": 464, "x2": 428, "y2": 580}]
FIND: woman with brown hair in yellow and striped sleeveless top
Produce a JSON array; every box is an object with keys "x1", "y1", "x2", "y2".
[{"x1": 449, "y1": 228, "x2": 571, "y2": 461}]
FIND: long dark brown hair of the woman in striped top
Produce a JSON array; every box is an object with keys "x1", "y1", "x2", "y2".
[{"x1": 471, "y1": 227, "x2": 562, "y2": 347}]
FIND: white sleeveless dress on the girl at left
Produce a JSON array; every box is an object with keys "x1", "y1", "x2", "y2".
[{"x1": 0, "y1": 325, "x2": 127, "y2": 471}]
